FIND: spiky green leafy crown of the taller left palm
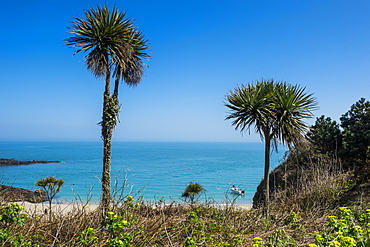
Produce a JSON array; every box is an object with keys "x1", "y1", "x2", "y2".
[{"x1": 66, "y1": 5, "x2": 150, "y2": 90}]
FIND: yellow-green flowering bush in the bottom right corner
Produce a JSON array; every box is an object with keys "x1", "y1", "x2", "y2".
[{"x1": 309, "y1": 207, "x2": 370, "y2": 247}]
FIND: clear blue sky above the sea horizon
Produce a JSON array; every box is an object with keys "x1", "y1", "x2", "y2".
[{"x1": 0, "y1": 0, "x2": 370, "y2": 141}]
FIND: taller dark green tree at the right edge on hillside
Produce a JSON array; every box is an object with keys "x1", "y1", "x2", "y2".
[{"x1": 340, "y1": 98, "x2": 370, "y2": 165}]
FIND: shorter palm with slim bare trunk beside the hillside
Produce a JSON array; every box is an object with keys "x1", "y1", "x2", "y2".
[{"x1": 225, "y1": 80, "x2": 316, "y2": 215}]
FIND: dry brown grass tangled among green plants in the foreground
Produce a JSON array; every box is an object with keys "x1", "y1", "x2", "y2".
[{"x1": 3, "y1": 193, "x2": 368, "y2": 246}]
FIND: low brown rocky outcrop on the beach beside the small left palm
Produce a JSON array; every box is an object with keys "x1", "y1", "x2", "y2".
[{"x1": 0, "y1": 185, "x2": 46, "y2": 203}]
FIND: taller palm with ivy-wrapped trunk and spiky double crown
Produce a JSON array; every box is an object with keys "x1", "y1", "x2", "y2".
[{"x1": 65, "y1": 5, "x2": 150, "y2": 211}]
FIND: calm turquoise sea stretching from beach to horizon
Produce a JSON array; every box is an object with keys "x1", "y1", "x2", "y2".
[{"x1": 0, "y1": 142, "x2": 285, "y2": 204}]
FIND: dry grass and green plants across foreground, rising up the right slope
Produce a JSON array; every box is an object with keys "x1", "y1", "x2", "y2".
[{"x1": 0, "y1": 161, "x2": 370, "y2": 247}]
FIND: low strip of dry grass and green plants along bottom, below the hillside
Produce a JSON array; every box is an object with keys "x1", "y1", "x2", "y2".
[{"x1": 0, "y1": 196, "x2": 370, "y2": 247}]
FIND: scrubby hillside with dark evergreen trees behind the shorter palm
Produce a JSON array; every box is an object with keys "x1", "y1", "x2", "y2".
[{"x1": 253, "y1": 98, "x2": 370, "y2": 211}]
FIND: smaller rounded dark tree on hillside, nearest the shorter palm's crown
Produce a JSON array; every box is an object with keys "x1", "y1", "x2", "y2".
[{"x1": 306, "y1": 115, "x2": 342, "y2": 156}]
